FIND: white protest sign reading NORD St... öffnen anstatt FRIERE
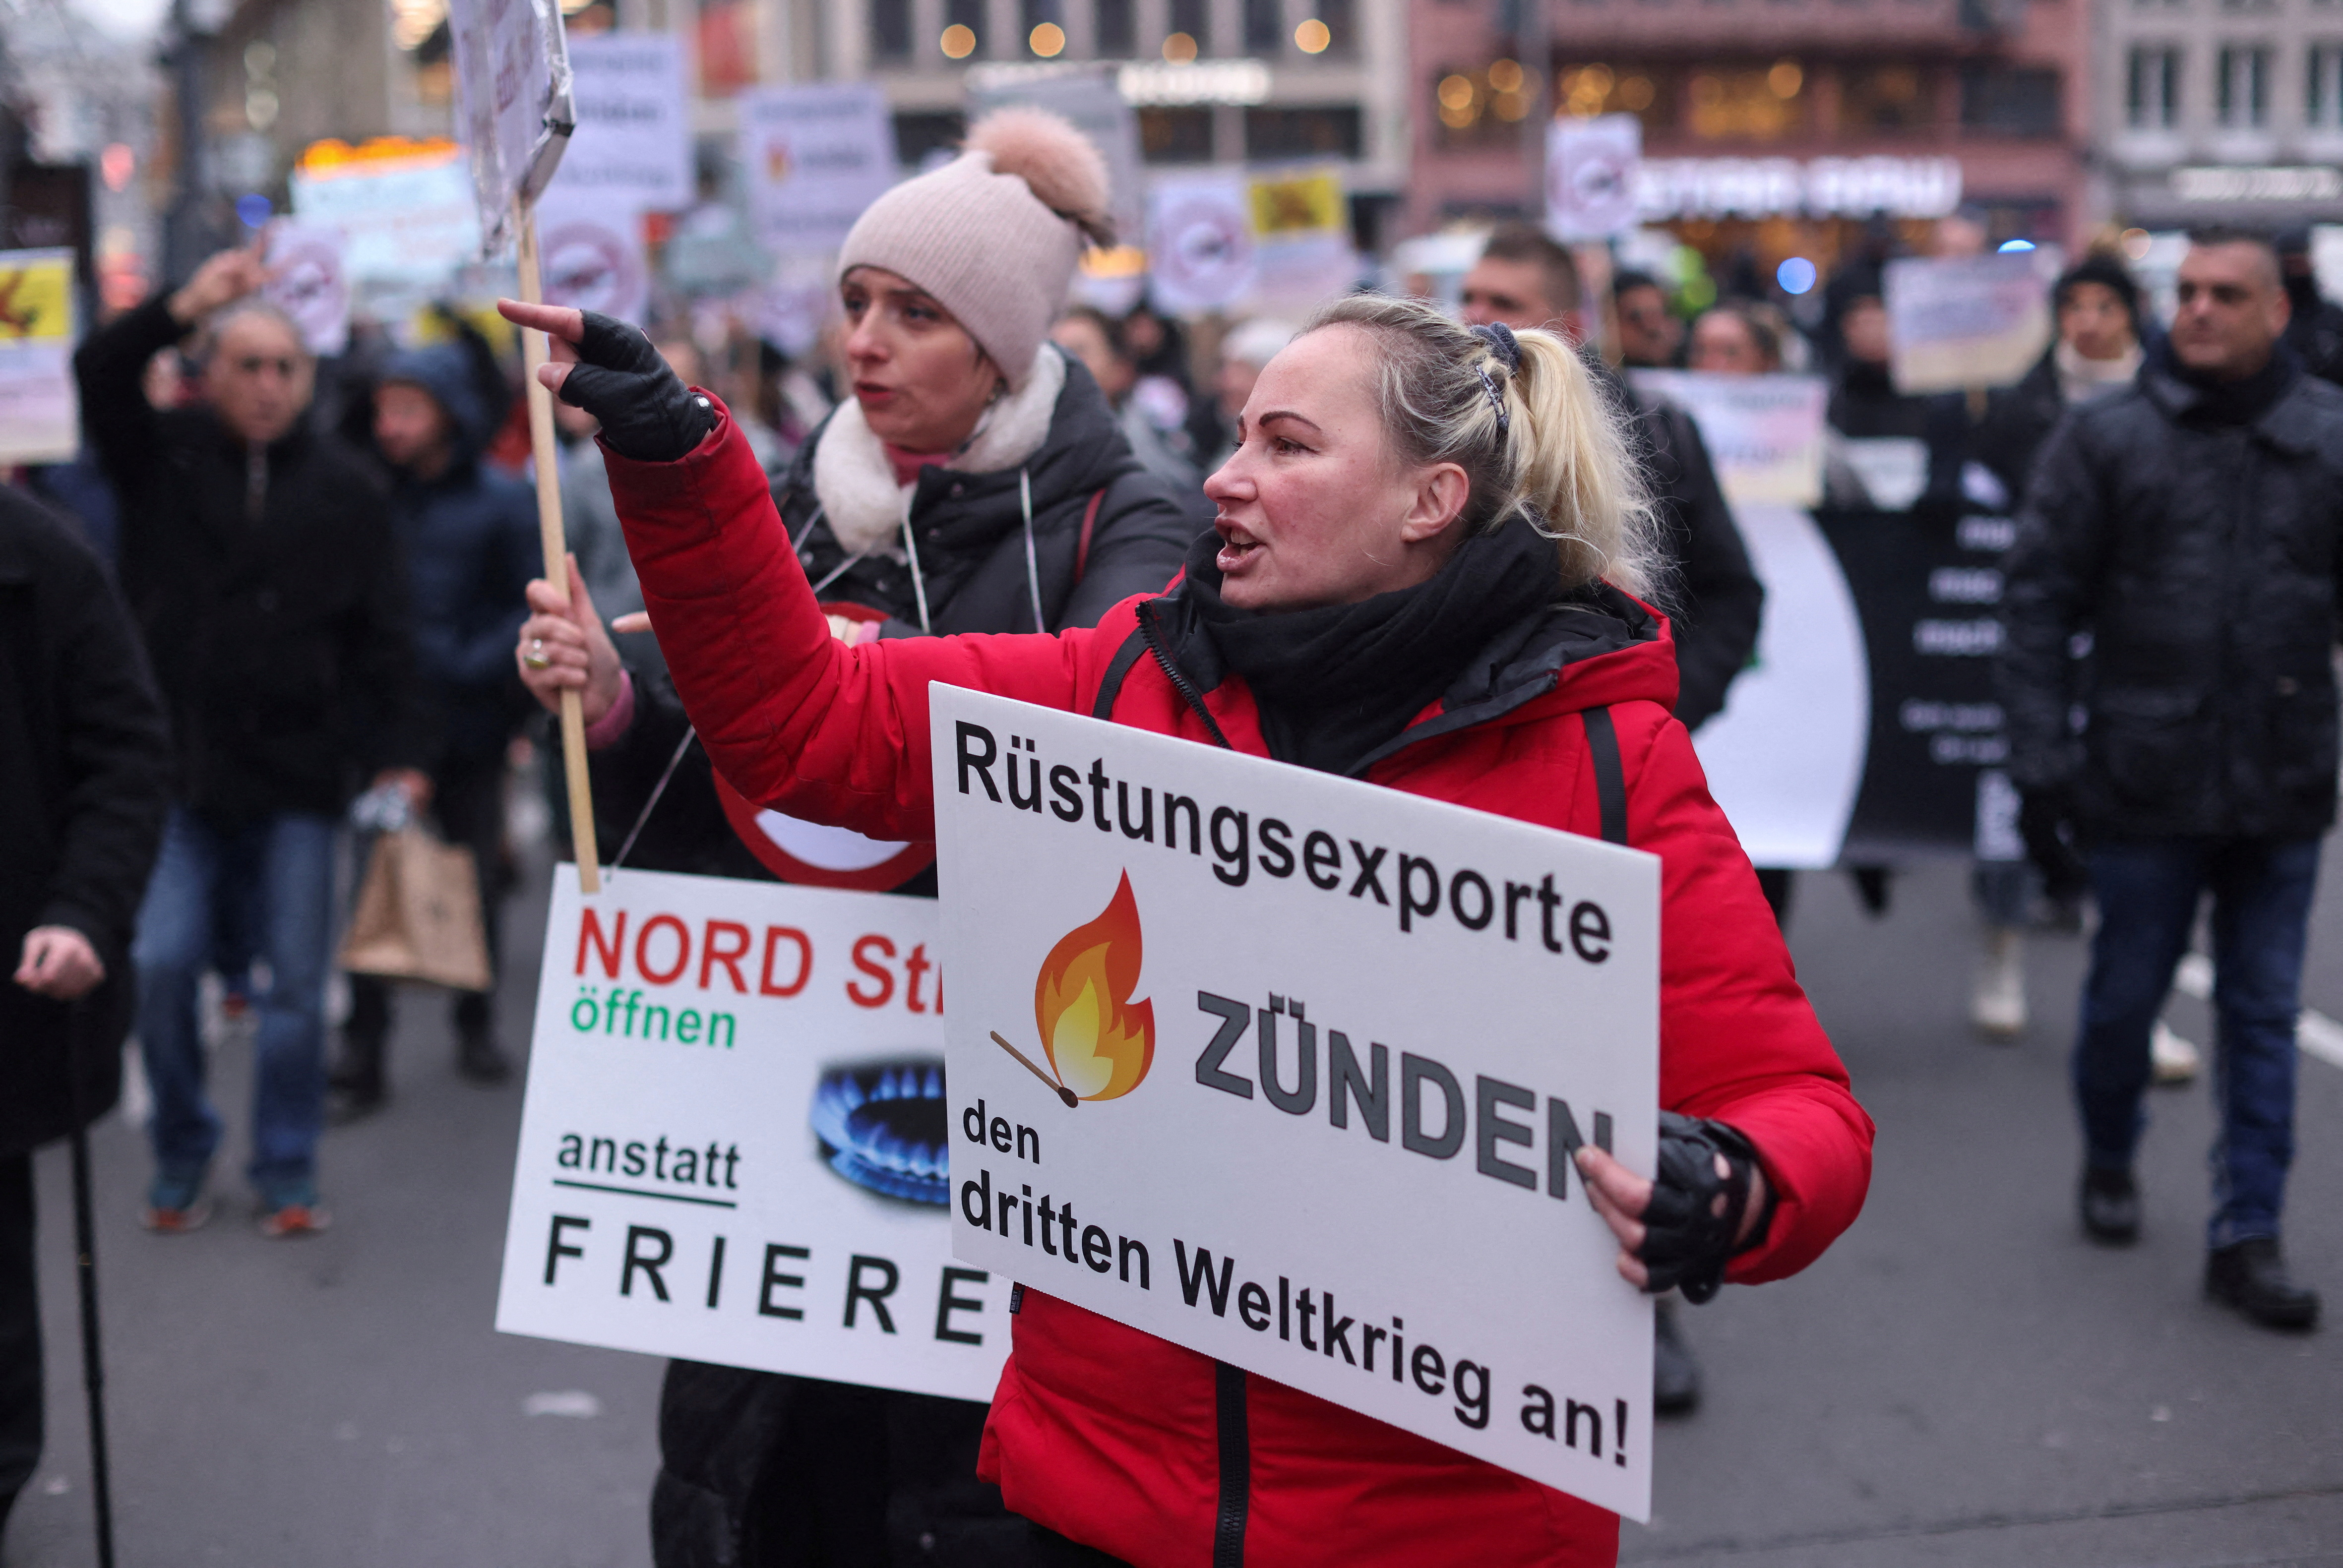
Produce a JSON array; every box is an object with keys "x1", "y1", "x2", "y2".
[{"x1": 496, "y1": 870, "x2": 1010, "y2": 1399}]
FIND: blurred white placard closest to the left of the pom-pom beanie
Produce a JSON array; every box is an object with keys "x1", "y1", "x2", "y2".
[{"x1": 736, "y1": 82, "x2": 895, "y2": 255}]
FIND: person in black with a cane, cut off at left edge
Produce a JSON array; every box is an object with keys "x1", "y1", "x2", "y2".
[{"x1": 0, "y1": 487, "x2": 171, "y2": 1528}]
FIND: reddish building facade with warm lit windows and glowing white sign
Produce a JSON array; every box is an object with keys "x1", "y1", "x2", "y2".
[{"x1": 1408, "y1": 0, "x2": 2093, "y2": 272}]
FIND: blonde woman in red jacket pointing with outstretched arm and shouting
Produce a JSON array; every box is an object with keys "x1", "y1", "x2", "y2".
[{"x1": 504, "y1": 287, "x2": 1872, "y2": 1568}]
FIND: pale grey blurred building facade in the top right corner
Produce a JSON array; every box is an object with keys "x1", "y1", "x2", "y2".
[{"x1": 2093, "y1": 0, "x2": 2343, "y2": 230}]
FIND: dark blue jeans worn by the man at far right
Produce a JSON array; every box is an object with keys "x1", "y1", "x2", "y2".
[{"x1": 2074, "y1": 839, "x2": 2320, "y2": 1247}]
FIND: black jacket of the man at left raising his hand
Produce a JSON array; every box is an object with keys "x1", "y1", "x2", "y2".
[{"x1": 75, "y1": 300, "x2": 424, "y2": 818}]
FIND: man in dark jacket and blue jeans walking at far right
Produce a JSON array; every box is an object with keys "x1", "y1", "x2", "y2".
[{"x1": 2001, "y1": 232, "x2": 2343, "y2": 1329}]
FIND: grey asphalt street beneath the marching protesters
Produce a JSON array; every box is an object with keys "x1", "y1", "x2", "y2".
[{"x1": 0, "y1": 830, "x2": 2343, "y2": 1568}]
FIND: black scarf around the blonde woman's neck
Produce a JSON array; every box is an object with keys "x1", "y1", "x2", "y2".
[{"x1": 1183, "y1": 516, "x2": 1565, "y2": 774}]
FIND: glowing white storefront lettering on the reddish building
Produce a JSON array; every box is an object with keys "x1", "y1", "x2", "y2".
[{"x1": 1635, "y1": 157, "x2": 1961, "y2": 223}]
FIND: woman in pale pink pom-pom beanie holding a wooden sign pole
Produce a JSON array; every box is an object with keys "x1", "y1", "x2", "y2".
[{"x1": 513, "y1": 113, "x2": 1195, "y2": 1568}]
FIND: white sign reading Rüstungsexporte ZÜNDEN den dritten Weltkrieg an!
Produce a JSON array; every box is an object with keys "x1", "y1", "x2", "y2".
[{"x1": 930, "y1": 684, "x2": 1659, "y2": 1519}]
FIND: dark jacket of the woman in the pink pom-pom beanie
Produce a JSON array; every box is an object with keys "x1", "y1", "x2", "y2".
[{"x1": 642, "y1": 349, "x2": 1202, "y2": 1568}]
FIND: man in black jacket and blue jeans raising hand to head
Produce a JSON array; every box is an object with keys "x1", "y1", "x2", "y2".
[{"x1": 75, "y1": 251, "x2": 429, "y2": 1235}]
